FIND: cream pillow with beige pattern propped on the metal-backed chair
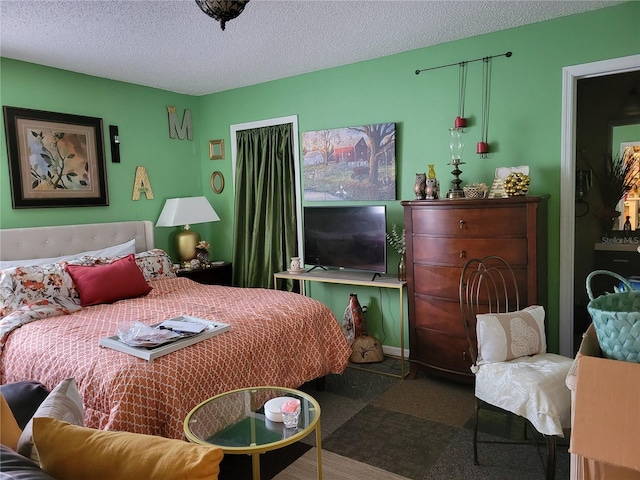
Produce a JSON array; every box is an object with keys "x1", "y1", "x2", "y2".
[{"x1": 476, "y1": 305, "x2": 547, "y2": 365}]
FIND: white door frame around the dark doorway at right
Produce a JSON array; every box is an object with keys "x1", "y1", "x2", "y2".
[{"x1": 559, "y1": 55, "x2": 640, "y2": 357}]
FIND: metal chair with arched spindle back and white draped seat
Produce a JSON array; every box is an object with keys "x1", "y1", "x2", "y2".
[{"x1": 460, "y1": 256, "x2": 572, "y2": 480}]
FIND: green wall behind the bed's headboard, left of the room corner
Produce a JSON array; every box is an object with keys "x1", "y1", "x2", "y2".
[{"x1": 0, "y1": 58, "x2": 208, "y2": 256}]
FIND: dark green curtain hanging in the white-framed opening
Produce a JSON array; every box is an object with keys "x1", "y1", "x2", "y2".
[{"x1": 233, "y1": 124, "x2": 297, "y2": 288}]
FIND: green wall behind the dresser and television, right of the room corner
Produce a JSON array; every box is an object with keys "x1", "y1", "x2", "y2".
[{"x1": 201, "y1": 2, "x2": 640, "y2": 351}]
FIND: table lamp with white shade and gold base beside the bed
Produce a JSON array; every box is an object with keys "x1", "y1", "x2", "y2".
[{"x1": 156, "y1": 197, "x2": 220, "y2": 262}]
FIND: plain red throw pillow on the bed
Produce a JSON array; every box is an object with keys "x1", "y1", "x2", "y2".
[{"x1": 66, "y1": 254, "x2": 152, "y2": 307}]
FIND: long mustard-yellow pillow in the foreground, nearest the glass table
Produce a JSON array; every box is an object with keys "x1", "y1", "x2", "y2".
[{"x1": 33, "y1": 417, "x2": 222, "y2": 480}]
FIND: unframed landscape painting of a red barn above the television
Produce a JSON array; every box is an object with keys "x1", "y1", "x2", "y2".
[{"x1": 302, "y1": 123, "x2": 396, "y2": 202}]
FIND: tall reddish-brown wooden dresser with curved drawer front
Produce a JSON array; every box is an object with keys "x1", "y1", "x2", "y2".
[{"x1": 401, "y1": 196, "x2": 547, "y2": 381}]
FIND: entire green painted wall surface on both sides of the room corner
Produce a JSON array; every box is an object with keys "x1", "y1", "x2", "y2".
[{"x1": 0, "y1": 2, "x2": 640, "y2": 351}]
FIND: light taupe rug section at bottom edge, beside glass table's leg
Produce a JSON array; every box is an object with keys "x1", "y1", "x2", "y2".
[{"x1": 274, "y1": 448, "x2": 407, "y2": 480}]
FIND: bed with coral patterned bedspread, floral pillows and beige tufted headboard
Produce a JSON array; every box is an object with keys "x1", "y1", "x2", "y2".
[{"x1": 0, "y1": 221, "x2": 351, "y2": 438}]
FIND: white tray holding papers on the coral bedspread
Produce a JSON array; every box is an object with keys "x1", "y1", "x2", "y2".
[{"x1": 99, "y1": 315, "x2": 231, "y2": 362}]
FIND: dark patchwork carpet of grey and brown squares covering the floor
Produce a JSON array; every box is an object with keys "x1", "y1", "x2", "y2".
[{"x1": 220, "y1": 360, "x2": 569, "y2": 480}]
